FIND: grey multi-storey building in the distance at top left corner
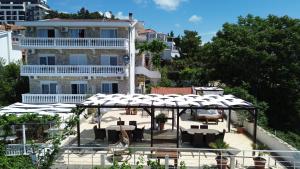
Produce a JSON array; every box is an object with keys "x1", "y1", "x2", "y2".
[{"x1": 0, "y1": 0, "x2": 50, "y2": 24}]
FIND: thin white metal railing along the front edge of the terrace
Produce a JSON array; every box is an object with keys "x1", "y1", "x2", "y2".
[{"x1": 53, "y1": 146, "x2": 300, "y2": 169}]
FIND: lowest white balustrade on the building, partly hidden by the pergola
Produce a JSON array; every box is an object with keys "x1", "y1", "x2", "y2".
[{"x1": 22, "y1": 94, "x2": 87, "y2": 104}]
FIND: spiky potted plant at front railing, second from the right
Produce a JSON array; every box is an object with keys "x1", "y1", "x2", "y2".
[{"x1": 209, "y1": 139, "x2": 229, "y2": 169}]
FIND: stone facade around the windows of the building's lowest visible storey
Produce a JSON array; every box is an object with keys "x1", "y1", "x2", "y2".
[{"x1": 29, "y1": 77, "x2": 129, "y2": 94}]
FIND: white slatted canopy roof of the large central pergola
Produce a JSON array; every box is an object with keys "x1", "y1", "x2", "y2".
[{"x1": 77, "y1": 93, "x2": 255, "y2": 109}]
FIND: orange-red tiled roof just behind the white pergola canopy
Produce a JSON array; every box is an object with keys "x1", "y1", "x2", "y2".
[{"x1": 151, "y1": 87, "x2": 193, "y2": 94}]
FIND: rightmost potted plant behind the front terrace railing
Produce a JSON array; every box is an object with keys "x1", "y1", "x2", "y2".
[{"x1": 252, "y1": 144, "x2": 268, "y2": 169}]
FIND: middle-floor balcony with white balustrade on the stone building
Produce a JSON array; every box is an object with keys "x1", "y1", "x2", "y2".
[{"x1": 21, "y1": 65, "x2": 127, "y2": 77}]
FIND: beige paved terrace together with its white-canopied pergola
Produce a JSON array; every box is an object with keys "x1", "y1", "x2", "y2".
[{"x1": 53, "y1": 94, "x2": 299, "y2": 168}]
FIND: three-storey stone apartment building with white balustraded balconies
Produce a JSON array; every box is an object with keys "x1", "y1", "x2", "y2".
[{"x1": 16, "y1": 15, "x2": 160, "y2": 104}]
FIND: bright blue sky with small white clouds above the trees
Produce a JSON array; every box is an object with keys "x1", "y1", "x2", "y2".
[{"x1": 48, "y1": 0, "x2": 300, "y2": 42}]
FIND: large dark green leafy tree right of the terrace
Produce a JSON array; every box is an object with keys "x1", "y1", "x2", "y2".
[{"x1": 203, "y1": 15, "x2": 300, "y2": 129}]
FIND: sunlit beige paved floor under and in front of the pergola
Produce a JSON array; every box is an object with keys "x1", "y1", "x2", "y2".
[{"x1": 52, "y1": 109, "x2": 284, "y2": 168}]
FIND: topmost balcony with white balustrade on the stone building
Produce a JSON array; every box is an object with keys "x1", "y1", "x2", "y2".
[{"x1": 19, "y1": 37, "x2": 128, "y2": 50}]
